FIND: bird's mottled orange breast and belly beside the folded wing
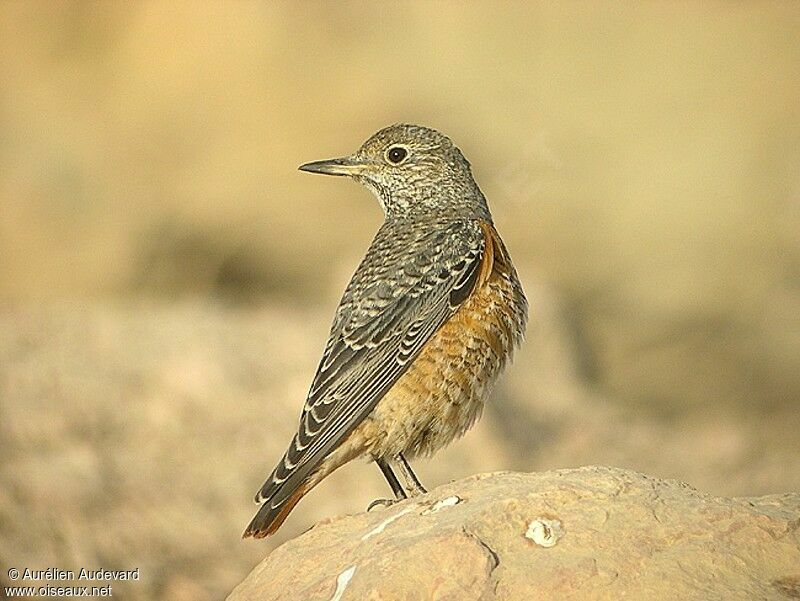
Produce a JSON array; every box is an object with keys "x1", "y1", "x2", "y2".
[{"x1": 348, "y1": 224, "x2": 527, "y2": 457}]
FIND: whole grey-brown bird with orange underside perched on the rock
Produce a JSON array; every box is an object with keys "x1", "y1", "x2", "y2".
[{"x1": 243, "y1": 124, "x2": 528, "y2": 538}]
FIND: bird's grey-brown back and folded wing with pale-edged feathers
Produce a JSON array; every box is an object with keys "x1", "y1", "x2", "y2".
[{"x1": 256, "y1": 221, "x2": 491, "y2": 508}]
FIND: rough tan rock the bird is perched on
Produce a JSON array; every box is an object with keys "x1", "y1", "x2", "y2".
[{"x1": 228, "y1": 467, "x2": 800, "y2": 601}]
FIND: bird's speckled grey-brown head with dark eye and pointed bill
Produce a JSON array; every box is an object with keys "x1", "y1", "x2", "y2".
[{"x1": 300, "y1": 124, "x2": 491, "y2": 221}]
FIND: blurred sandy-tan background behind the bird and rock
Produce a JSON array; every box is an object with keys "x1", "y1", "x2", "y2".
[{"x1": 0, "y1": 0, "x2": 800, "y2": 601}]
